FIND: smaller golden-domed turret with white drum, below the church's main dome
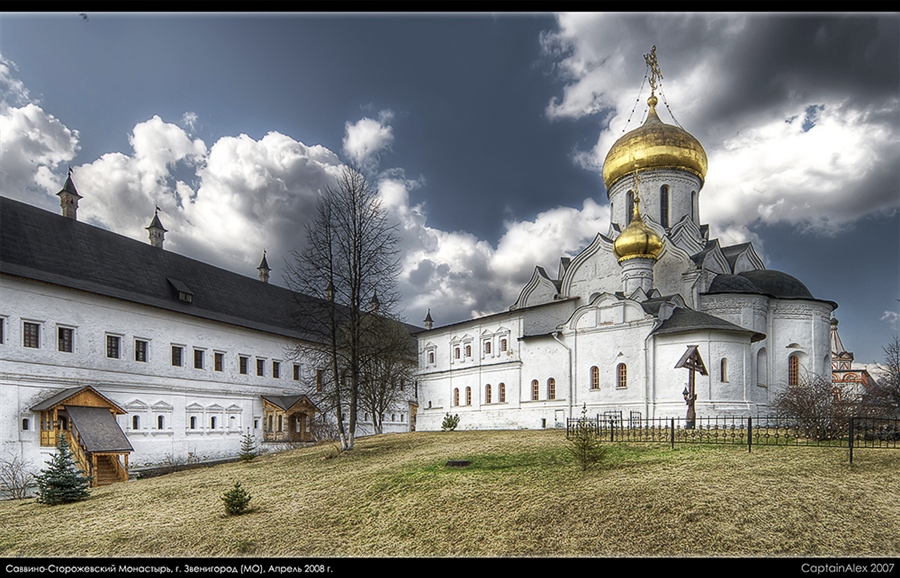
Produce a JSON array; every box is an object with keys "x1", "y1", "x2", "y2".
[{"x1": 613, "y1": 182, "x2": 663, "y2": 295}]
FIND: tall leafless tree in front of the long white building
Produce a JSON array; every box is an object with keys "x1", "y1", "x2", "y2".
[{"x1": 285, "y1": 167, "x2": 399, "y2": 450}]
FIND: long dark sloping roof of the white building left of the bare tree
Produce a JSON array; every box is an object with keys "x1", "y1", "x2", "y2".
[{"x1": 0, "y1": 197, "x2": 327, "y2": 341}]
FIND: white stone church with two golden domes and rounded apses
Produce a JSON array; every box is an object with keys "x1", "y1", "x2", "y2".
[{"x1": 417, "y1": 50, "x2": 837, "y2": 430}]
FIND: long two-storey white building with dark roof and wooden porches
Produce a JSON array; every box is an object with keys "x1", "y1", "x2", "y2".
[{"x1": 0, "y1": 175, "x2": 415, "y2": 483}]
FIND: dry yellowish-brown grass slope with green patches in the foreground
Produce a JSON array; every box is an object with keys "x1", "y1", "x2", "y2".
[{"x1": 0, "y1": 431, "x2": 900, "y2": 556}]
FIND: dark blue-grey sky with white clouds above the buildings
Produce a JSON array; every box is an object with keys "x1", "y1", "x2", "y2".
[{"x1": 0, "y1": 13, "x2": 900, "y2": 363}]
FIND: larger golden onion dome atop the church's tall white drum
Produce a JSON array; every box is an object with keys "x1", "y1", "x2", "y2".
[{"x1": 603, "y1": 94, "x2": 707, "y2": 191}]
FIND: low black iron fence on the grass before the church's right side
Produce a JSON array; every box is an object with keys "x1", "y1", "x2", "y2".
[{"x1": 566, "y1": 412, "x2": 900, "y2": 462}]
